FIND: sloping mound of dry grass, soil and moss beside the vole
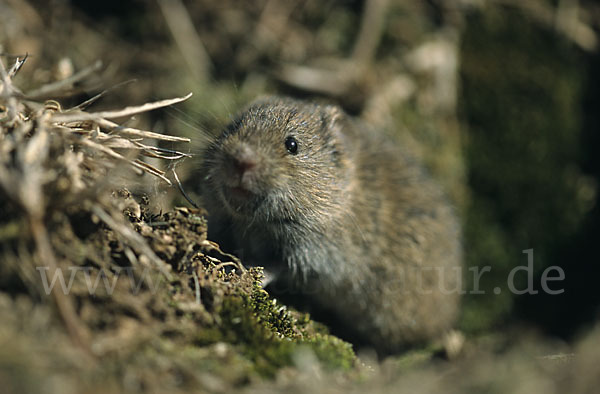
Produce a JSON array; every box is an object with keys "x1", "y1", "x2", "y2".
[{"x1": 0, "y1": 53, "x2": 355, "y2": 392}]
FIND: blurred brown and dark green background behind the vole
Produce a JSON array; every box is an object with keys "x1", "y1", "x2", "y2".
[{"x1": 0, "y1": 0, "x2": 600, "y2": 340}]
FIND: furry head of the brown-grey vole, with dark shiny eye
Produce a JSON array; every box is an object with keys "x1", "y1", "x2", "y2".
[{"x1": 203, "y1": 98, "x2": 351, "y2": 223}]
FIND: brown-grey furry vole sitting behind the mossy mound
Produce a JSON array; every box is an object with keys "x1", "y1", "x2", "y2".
[{"x1": 201, "y1": 97, "x2": 462, "y2": 354}]
